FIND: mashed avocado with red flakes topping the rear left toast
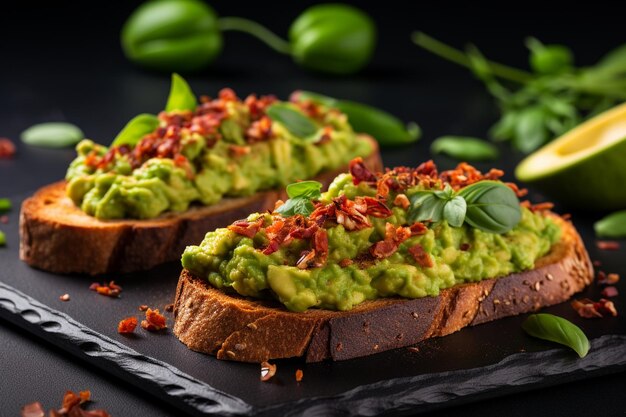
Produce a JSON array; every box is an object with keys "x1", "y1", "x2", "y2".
[{"x1": 66, "y1": 89, "x2": 373, "y2": 219}]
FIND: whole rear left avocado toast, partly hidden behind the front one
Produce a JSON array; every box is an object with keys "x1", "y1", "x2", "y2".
[{"x1": 20, "y1": 84, "x2": 381, "y2": 275}]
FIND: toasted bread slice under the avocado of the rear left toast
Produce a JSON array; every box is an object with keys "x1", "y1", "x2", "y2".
[{"x1": 20, "y1": 135, "x2": 382, "y2": 275}]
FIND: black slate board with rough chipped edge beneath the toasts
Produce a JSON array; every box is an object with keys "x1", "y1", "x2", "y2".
[{"x1": 0, "y1": 191, "x2": 626, "y2": 415}]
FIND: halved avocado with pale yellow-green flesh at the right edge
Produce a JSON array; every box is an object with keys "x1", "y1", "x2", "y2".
[{"x1": 515, "y1": 103, "x2": 626, "y2": 210}]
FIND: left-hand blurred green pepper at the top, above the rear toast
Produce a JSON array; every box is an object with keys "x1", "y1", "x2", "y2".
[{"x1": 122, "y1": 0, "x2": 222, "y2": 71}]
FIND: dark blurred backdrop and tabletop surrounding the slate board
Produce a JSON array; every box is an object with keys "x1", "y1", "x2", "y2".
[{"x1": 0, "y1": 1, "x2": 626, "y2": 416}]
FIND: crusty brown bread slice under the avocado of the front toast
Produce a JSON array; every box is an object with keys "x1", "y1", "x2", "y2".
[{"x1": 173, "y1": 214, "x2": 593, "y2": 362}]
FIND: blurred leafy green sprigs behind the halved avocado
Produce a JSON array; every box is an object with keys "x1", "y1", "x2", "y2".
[{"x1": 412, "y1": 32, "x2": 626, "y2": 153}]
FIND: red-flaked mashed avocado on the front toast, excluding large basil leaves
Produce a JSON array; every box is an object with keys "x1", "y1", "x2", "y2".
[{"x1": 182, "y1": 159, "x2": 560, "y2": 311}]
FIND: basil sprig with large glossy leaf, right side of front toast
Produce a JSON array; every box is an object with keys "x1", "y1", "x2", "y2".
[{"x1": 407, "y1": 181, "x2": 521, "y2": 234}]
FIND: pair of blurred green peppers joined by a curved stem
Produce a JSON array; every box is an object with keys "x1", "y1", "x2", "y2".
[{"x1": 122, "y1": 0, "x2": 376, "y2": 74}]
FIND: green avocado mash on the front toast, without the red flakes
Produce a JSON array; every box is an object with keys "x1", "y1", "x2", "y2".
[{"x1": 182, "y1": 163, "x2": 560, "y2": 311}]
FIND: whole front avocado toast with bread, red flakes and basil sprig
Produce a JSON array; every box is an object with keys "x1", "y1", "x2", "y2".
[{"x1": 173, "y1": 159, "x2": 593, "y2": 362}]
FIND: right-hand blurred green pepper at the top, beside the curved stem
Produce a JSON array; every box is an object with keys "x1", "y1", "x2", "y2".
[{"x1": 289, "y1": 4, "x2": 376, "y2": 74}]
